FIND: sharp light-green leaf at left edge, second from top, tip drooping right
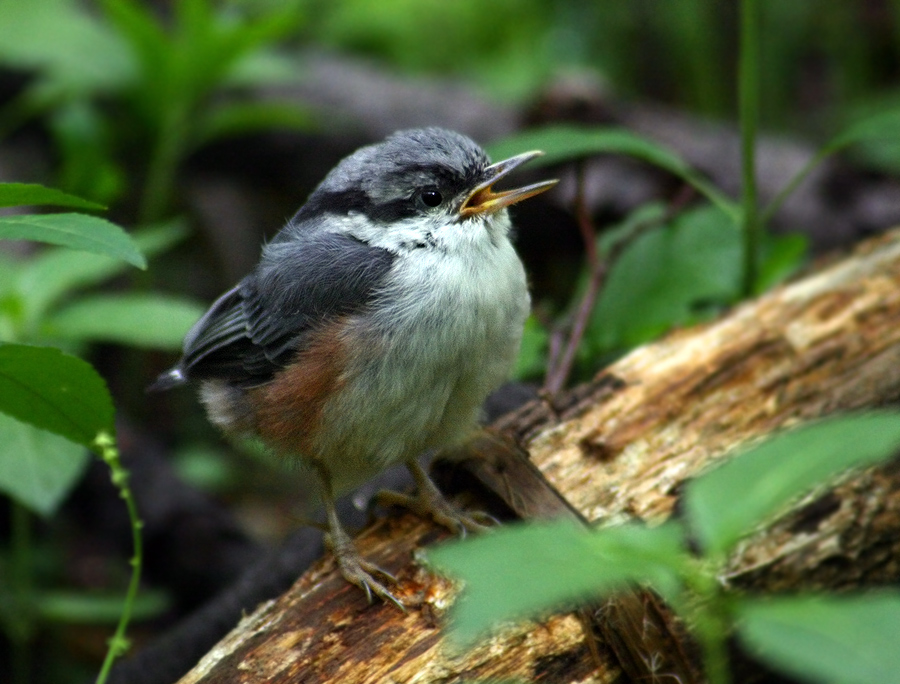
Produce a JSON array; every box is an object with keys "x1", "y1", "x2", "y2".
[{"x1": 0, "y1": 214, "x2": 147, "y2": 268}]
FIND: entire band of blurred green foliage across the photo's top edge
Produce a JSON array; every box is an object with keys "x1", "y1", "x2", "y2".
[{"x1": 0, "y1": 0, "x2": 900, "y2": 221}]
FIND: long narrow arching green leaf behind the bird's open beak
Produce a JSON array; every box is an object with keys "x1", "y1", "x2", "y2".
[{"x1": 488, "y1": 126, "x2": 740, "y2": 221}]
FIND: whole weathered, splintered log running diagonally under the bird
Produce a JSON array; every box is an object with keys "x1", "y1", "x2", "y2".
[{"x1": 182, "y1": 233, "x2": 900, "y2": 684}]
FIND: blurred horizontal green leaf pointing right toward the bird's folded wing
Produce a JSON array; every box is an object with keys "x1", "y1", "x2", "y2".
[{"x1": 45, "y1": 294, "x2": 206, "y2": 351}]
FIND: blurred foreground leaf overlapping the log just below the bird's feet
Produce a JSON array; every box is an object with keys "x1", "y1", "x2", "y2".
[{"x1": 428, "y1": 521, "x2": 684, "y2": 642}]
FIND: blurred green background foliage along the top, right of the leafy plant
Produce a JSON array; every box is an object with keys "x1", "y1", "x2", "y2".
[{"x1": 296, "y1": 0, "x2": 900, "y2": 132}]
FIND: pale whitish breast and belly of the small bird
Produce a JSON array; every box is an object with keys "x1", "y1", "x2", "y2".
[{"x1": 317, "y1": 238, "x2": 530, "y2": 489}]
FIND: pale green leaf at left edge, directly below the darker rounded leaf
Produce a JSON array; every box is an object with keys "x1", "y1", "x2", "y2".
[{"x1": 0, "y1": 413, "x2": 90, "y2": 516}]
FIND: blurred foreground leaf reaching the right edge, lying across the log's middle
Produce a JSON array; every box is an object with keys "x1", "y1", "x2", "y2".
[{"x1": 685, "y1": 411, "x2": 900, "y2": 554}]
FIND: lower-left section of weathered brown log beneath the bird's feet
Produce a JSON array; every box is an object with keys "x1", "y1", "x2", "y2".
[{"x1": 181, "y1": 515, "x2": 612, "y2": 684}]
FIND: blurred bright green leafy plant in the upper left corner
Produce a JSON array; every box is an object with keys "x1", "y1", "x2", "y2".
[{"x1": 0, "y1": 0, "x2": 312, "y2": 222}]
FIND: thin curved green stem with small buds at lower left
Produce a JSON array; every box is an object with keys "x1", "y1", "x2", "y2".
[{"x1": 94, "y1": 433, "x2": 144, "y2": 684}]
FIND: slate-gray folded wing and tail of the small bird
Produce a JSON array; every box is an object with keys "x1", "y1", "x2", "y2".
[{"x1": 151, "y1": 232, "x2": 394, "y2": 389}]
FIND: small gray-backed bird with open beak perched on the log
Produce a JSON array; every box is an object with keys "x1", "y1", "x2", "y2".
[{"x1": 149, "y1": 127, "x2": 557, "y2": 609}]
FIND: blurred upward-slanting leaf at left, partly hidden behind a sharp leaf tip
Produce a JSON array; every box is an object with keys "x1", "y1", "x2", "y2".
[{"x1": 18, "y1": 221, "x2": 187, "y2": 320}]
